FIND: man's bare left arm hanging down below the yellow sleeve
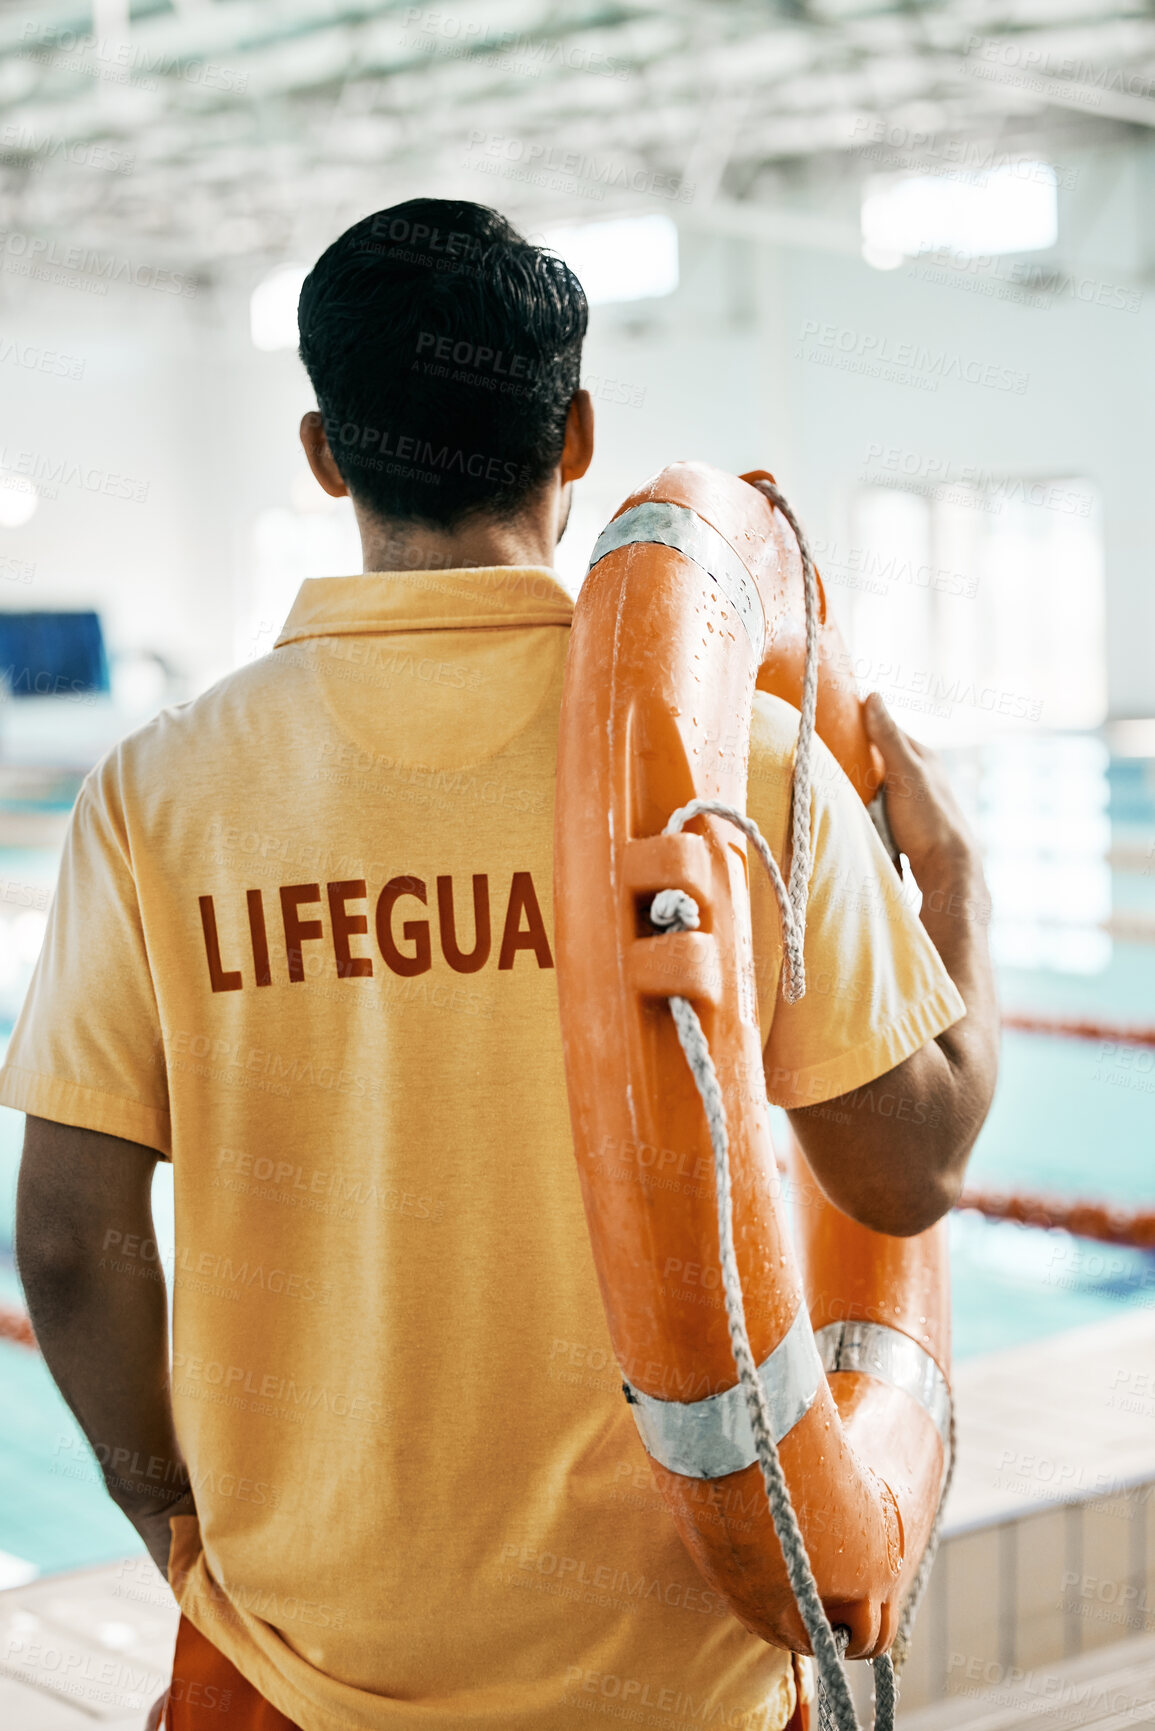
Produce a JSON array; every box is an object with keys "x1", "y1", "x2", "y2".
[{"x1": 16, "y1": 1116, "x2": 192, "y2": 1575}]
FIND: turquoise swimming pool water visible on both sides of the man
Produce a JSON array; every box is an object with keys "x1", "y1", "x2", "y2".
[{"x1": 0, "y1": 741, "x2": 1155, "y2": 1579}]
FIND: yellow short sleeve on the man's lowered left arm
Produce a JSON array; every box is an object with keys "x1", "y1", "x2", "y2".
[{"x1": 0, "y1": 753, "x2": 171, "y2": 1155}]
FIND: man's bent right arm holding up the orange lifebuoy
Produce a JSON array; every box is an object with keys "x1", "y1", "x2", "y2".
[{"x1": 790, "y1": 694, "x2": 999, "y2": 1238}]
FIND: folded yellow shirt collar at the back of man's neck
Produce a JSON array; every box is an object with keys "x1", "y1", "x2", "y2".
[{"x1": 274, "y1": 564, "x2": 573, "y2": 649}]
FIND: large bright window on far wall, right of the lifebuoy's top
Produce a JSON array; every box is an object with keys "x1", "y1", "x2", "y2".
[{"x1": 834, "y1": 476, "x2": 1107, "y2": 746}]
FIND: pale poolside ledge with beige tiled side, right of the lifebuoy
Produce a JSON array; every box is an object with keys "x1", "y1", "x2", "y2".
[{"x1": 904, "y1": 1307, "x2": 1155, "y2": 1728}]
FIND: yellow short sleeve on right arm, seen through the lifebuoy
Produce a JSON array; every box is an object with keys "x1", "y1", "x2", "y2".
[{"x1": 748, "y1": 696, "x2": 966, "y2": 1108}]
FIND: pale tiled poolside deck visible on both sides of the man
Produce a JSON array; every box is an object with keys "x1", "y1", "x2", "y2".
[{"x1": 0, "y1": 1309, "x2": 1155, "y2": 1731}]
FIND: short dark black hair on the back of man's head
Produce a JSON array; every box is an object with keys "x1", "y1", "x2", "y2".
[{"x1": 298, "y1": 199, "x2": 589, "y2": 528}]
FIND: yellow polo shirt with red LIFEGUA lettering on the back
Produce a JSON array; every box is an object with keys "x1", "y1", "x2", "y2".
[{"x1": 0, "y1": 568, "x2": 963, "y2": 1731}]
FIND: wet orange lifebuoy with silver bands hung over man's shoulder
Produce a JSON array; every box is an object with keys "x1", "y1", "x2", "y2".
[{"x1": 554, "y1": 462, "x2": 949, "y2": 1658}]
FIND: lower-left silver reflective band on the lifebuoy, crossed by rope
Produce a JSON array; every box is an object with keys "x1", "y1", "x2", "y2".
[{"x1": 625, "y1": 1305, "x2": 823, "y2": 1478}]
